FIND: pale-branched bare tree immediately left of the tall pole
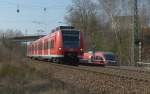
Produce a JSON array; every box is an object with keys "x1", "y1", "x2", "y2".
[{"x1": 98, "y1": 0, "x2": 133, "y2": 63}]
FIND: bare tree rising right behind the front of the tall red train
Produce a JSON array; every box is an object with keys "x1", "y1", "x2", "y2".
[{"x1": 66, "y1": 0, "x2": 99, "y2": 49}]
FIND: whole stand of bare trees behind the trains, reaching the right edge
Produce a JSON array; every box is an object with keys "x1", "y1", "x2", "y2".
[{"x1": 66, "y1": 0, "x2": 150, "y2": 65}]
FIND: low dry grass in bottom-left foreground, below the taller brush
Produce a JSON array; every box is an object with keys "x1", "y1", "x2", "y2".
[{"x1": 0, "y1": 62, "x2": 87, "y2": 94}]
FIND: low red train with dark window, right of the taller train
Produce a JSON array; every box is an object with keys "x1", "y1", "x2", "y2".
[{"x1": 81, "y1": 51, "x2": 117, "y2": 66}]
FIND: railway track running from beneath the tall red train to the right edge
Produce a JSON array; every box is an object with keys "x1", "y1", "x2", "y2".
[{"x1": 30, "y1": 61, "x2": 150, "y2": 82}]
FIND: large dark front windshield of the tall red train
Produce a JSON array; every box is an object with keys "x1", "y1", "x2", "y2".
[{"x1": 62, "y1": 31, "x2": 80, "y2": 48}]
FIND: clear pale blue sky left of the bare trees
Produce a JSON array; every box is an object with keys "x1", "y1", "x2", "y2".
[{"x1": 0, "y1": 0, "x2": 71, "y2": 35}]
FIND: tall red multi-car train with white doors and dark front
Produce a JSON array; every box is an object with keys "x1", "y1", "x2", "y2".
[{"x1": 27, "y1": 26, "x2": 83, "y2": 64}]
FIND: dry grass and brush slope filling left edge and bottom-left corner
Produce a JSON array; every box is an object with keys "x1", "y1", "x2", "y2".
[{"x1": 0, "y1": 40, "x2": 87, "y2": 94}]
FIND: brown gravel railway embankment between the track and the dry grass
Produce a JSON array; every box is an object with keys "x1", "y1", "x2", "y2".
[{"x1": 33, "y1": 62, "x2": 150, "y2": 94}]
